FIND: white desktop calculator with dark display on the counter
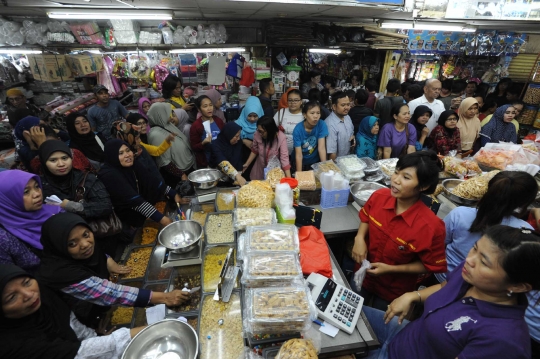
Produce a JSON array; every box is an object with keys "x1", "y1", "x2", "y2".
[{"x1": 306, "y1": 273, "x2": 364, "y2": 334}]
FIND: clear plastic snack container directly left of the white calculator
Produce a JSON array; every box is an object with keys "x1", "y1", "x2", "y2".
[{"x1": 244, "y1": 285, "x2": 316, "y2": 334}]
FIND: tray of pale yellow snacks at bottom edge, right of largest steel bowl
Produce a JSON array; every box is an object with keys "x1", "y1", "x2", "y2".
[{"x1": 199, "y1": 292, "x2": 244, "y2": 359}]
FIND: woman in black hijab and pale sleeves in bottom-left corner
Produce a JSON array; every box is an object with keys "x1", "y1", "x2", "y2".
[{"x1": 0, "y1": 265, "x2": 144, "y2": 359}]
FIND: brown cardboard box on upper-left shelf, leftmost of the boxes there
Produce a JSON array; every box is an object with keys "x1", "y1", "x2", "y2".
[{"x1": 27, "y1": 55, "x2": 73, "y2": 82}]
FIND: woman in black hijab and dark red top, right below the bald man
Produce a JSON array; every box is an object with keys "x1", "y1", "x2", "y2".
[{"x1": 429, "y1": 110, "x2": 461, "y2": 156}]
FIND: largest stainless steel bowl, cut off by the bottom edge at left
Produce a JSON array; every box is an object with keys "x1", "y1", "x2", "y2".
[{"x1": 122, "y1": 319, "x2": 199, "y2": 359}]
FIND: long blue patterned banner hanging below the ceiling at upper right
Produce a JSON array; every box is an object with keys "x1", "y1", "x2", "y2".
[{"x1": 404, "y1": 29, "x2": 527, "y2": 56}]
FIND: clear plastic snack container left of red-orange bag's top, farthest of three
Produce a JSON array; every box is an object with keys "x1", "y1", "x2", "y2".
[{"x1": 244, "y1": 224, "x2": 300, "y2": 254}]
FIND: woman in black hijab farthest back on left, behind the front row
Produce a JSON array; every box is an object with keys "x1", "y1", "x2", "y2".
[{"x1": 66, "y1": 113, "x2": 106, "y2": 170}]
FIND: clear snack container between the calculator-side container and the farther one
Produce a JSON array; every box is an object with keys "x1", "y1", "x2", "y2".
[{"x1": 242, "y1": 251, "x2": 303, "y2": 287}]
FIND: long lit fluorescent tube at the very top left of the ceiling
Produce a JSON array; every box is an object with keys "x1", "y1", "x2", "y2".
[{"x1": 47, "y1": 9, "x2": 172, "y2": 21}]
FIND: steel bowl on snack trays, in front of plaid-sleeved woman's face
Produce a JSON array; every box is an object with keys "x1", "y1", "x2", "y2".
[{"x1": 158, "y1": 221, "x2": 202, "y2": 253}]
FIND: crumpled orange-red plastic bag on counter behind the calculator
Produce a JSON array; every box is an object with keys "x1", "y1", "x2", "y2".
[{"x1": 298, "y1": 226, "x2": 332, "y2": 278}]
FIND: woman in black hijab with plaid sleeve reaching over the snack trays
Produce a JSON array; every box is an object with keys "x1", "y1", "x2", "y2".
[{"x1": 37, "y1": 213, "x2": 189, "y2": 323}]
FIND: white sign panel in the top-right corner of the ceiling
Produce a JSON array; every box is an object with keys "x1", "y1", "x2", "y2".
[{"x1": 445, "y1": 0, "x2": 540, "y2": 21}]
